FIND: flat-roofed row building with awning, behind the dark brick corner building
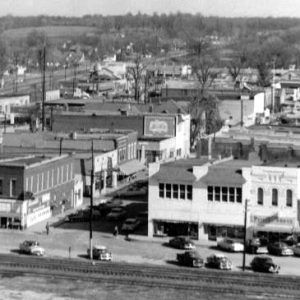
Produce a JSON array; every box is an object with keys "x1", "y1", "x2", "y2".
[{"x1": 2, "y1": 129, "x2": 141, "y2": 196}]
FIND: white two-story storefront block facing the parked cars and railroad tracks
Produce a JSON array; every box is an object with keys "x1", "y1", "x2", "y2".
[{"x1": 148, "y1": 158, "x2": 300, "y2": 239}]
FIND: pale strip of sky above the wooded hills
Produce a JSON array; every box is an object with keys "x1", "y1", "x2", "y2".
[{"x1": 0, "y1": 0, "x2": 300, "y2": 17}]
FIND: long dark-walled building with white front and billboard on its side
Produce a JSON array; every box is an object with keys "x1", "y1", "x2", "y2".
[{"x1": 53, "y1": 101, "x2": 190, "y2": 163}]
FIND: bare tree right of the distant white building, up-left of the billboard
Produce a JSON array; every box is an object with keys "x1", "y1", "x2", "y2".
[{"x1": 127, "y1": 54, "x2": 146, "y2": 102}]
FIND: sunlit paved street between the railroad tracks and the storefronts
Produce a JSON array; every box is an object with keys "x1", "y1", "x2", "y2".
[{"x1": 0, "y1": 216, "x2": 300, "y2": 275}]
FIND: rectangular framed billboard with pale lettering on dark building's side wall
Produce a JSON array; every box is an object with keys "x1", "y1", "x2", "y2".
[{"x1": 144, "y1": 116, "x2": 176, "y2": 137}]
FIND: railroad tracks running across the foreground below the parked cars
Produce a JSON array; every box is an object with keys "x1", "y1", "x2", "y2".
[{"x1": 0, "y1": 255, "x2": 300, "y2": 299}]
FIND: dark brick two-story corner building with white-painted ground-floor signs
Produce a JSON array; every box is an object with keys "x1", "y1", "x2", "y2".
[{"x1": 0, "y1": 155, "x2": 83, "y2": 229}]
